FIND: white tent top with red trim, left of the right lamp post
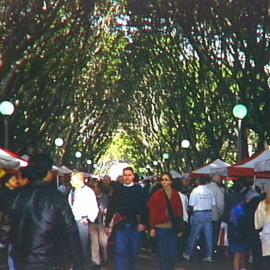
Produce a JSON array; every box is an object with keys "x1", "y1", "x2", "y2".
[{"x1": 191, "y1": 158, "x2": 231, "y2": 178}]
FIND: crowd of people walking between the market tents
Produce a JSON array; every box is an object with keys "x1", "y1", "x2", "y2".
[{"x1": 0, "y1": 154, "x2": 270, "y2": 270}]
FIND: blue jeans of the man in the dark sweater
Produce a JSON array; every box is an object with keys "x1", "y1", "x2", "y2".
[{"x1": 115, "y1": 223, "x2": 141, "y2": 270}]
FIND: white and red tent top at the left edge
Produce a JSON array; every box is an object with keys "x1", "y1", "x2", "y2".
[{"x1": 0, "y1": 147, "x2": 27, "y2": 170}]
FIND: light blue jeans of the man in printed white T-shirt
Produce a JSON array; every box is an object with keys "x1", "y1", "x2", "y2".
[{"x1": 185, "y1": 211, "x2": 213, "y2": 257}]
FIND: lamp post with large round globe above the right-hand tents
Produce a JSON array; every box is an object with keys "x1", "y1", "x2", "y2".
[{"x1": 233, "y1": 104, "x2": 247, "y2": 161}]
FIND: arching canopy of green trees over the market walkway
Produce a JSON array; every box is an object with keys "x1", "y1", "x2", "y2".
[{"x1": 0, "y1": 0, "x2": 270, "y2": 173}]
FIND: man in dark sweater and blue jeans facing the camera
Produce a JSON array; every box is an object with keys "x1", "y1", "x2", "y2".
[{"x1": 105, "y1": 167, "x2": 146, "y2": 270}]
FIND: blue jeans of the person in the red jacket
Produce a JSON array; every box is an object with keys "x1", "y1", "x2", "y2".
[{"x1": 157, "y1": 228, "x2": 177, "y2": 270}]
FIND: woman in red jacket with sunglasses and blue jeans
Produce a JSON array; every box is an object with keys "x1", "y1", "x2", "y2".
[{"x1": 148, "y1": 172, "x2": 183, "y2": 270}]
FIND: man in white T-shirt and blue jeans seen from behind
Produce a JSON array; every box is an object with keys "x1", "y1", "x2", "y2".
[{"x1": 183, "y1": 178, "x2": 215, "y2": 262}]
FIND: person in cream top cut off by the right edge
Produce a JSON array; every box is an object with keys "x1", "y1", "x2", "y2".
[{"x1": 254, "y1": 187, "x2": 270, "y2": 269}]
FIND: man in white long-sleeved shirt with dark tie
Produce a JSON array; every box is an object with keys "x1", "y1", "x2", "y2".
[{"x1": 68, "y1": 172, "x2": 99, "y2": 264}]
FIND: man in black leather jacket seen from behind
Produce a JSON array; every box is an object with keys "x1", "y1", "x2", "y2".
[{"x1": 10, "y1": 154, "x2": 83, "y2": 270}]
